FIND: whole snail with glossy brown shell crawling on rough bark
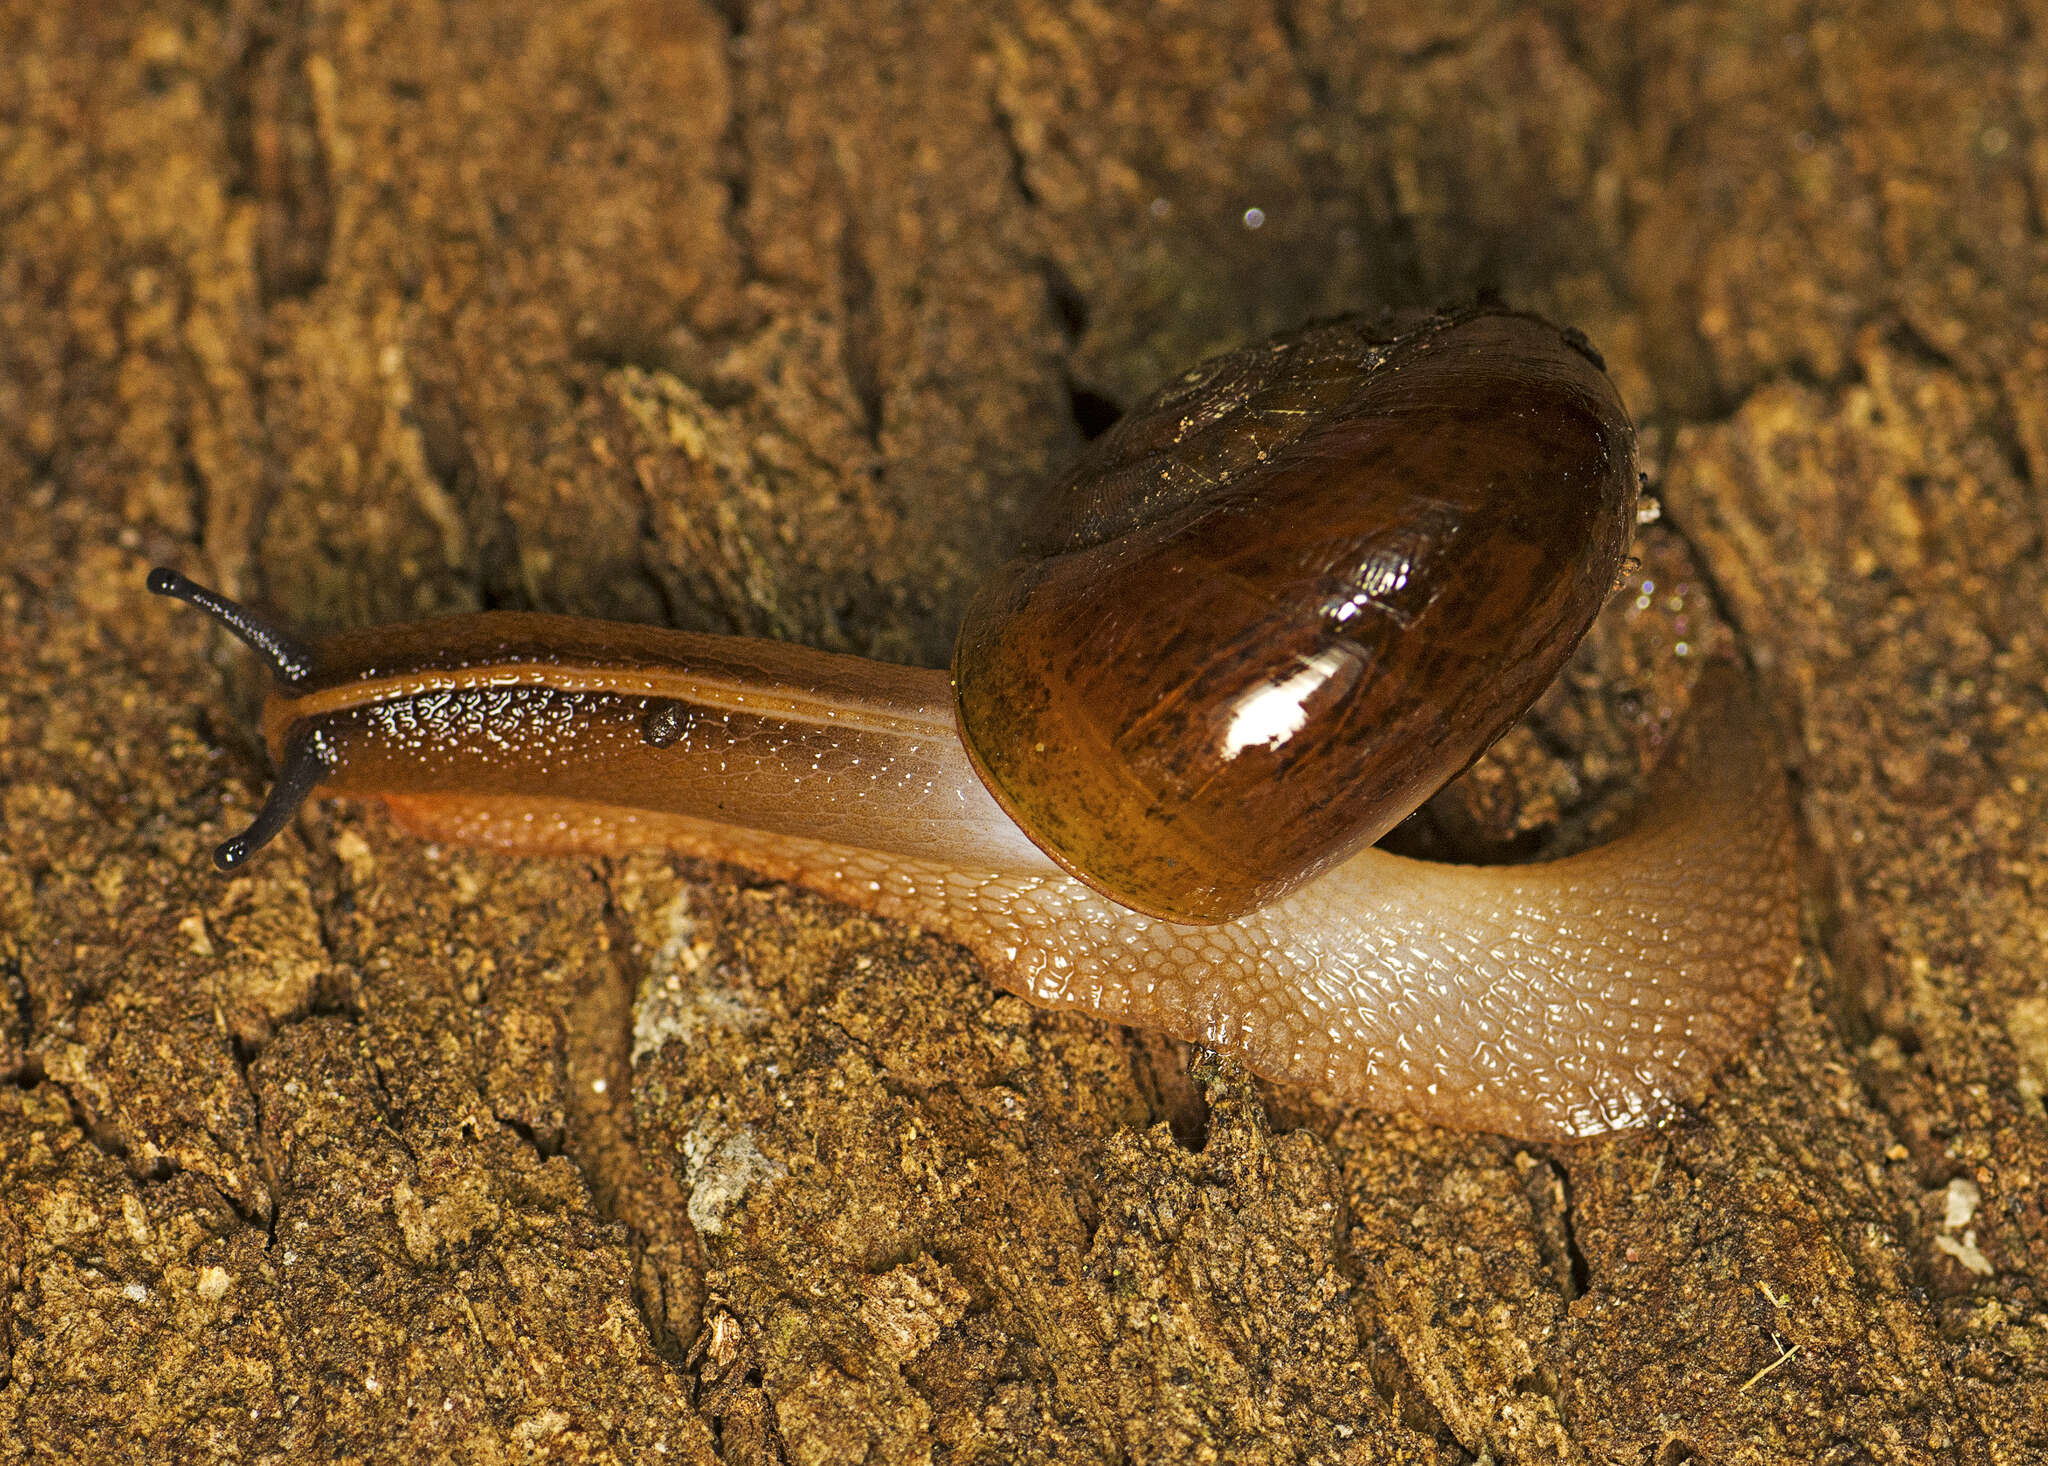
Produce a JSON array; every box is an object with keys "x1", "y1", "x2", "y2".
[{"x1": 150, "y1": 307, "x2": 1798, "y2": 1138}]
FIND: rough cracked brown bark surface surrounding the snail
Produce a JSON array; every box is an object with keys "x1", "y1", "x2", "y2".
[{"x1": 0, "y1": 0, "x2": 2048, "y2": 1466}]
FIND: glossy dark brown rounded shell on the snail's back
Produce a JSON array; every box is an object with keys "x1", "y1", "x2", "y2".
[{"x1": 952, "y1": 309, "x2": 1636, "y2": 921}]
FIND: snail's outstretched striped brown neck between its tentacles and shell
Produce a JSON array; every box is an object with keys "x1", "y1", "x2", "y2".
[{"x1": 264, "y1": 614, "x2": 1053, "y2": 872}]
